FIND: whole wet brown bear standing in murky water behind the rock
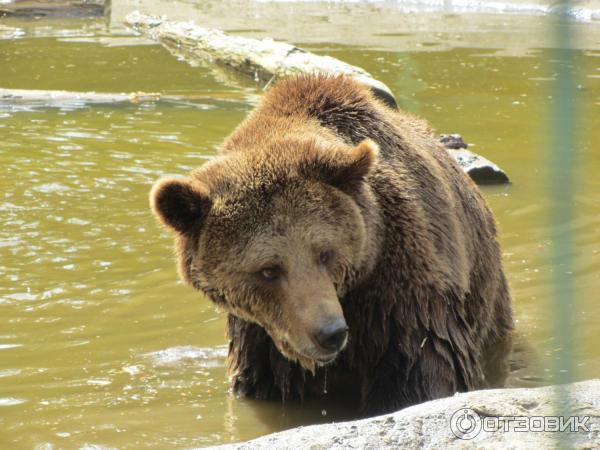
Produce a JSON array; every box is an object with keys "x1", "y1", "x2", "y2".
[{"x1": 151, "y1": 75, "x2": 512, "y2": 415}]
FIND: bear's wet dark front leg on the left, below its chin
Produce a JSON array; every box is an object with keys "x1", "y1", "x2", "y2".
[{"x1": 228, "y1": 314, "x2": 306, "y2": 400}]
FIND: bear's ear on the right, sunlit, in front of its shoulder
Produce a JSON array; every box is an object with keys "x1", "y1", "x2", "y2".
[{"x1": 304, "y1": 139, "x2": 379, "y2": 190}]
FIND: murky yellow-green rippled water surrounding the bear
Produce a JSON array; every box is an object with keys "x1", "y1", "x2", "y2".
[{"x1": 0, "y1": 16, "x2": 600, "y2": 449}]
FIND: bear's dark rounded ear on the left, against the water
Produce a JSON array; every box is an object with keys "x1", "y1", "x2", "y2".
[{"x1": 150, "y1": 178, "x2": 211, "y2": 233}]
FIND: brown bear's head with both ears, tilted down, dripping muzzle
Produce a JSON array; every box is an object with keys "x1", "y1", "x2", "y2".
[{"x1": 150, "y1": 139, "x2": 378, "y2": 370}]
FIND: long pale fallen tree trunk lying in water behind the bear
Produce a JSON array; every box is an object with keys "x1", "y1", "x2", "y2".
[{"x1": 125, "y1": 11, "x2": 510, "y2": 184}]
